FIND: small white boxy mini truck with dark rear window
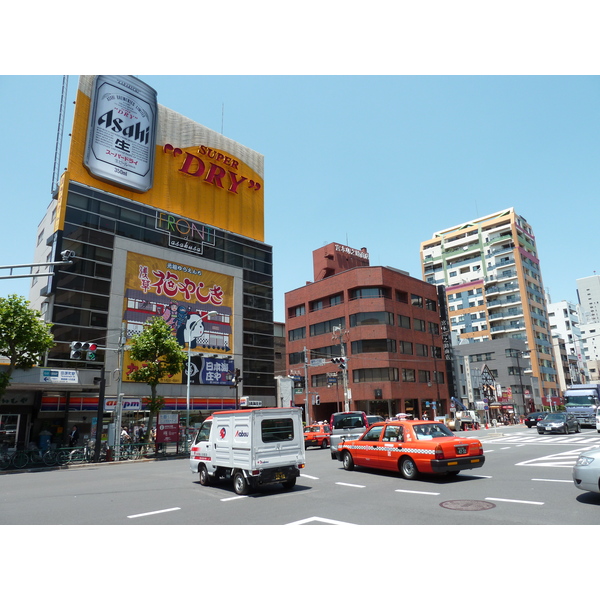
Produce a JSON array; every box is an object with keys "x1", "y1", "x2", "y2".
[{"x1": 190, "y1": 408, "x2": 305, "y2": 495}]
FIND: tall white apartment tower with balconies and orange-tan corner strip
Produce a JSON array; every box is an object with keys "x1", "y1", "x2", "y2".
[{"x1": 421, "y1": 208, "x2": 560, "y2": 401}]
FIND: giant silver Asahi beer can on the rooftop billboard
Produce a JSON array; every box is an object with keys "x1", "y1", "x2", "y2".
[{"x1": 84, "y1": 75, "x2": 158, "y2": 192}]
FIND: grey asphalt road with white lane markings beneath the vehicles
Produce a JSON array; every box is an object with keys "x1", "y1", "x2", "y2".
[{"x1": 0, "y1": 426, "x2": 600, "y2": 526}]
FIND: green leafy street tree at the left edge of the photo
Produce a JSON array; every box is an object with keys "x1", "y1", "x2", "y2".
[{"x1": 0, "y1": 294, "x2": 54, "y2": 397}]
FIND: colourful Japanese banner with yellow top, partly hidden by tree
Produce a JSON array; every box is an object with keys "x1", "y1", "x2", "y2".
[{"x1": 123, "y1": 252, "x2": 234, "y2": 385}]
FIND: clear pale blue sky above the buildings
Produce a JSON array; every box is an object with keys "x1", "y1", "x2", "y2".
[{"x1": 0, "y1": 75, "x2": 600, "y2": 321}]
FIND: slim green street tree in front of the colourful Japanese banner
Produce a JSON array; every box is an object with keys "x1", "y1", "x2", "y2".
[{"x1": 129, "y1": 317, "x2": 186, "y2": 442}]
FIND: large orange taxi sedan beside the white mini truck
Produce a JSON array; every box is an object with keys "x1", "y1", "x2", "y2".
[{"x1": 337, "y1": 421, "x2": 485, "y2": 479}]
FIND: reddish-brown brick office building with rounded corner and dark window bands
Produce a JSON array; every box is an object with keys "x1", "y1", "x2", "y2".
[{"x1": 285, "y1": 243, "x2": 450, "y2": 421}]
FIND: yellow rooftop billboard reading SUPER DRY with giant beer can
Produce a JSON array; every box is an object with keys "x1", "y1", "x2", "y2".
[{"x1": 64, "y1": 76, "x2": 264, "y2": 242}]
